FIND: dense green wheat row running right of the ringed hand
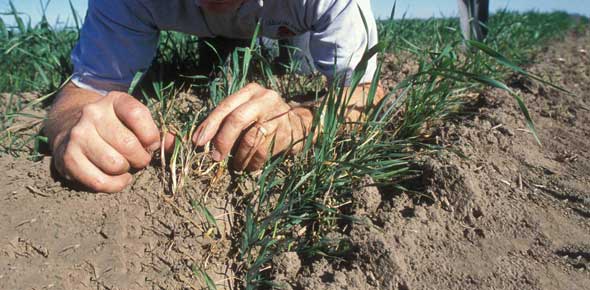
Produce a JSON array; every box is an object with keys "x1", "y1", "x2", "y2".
[{"x1": 231, "y1": 6, "x2": 588, "y2": 289}]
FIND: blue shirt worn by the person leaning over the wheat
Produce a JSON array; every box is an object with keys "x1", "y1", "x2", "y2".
[{"x1": 72, "y1": 0, "x2": 377, "y2": 94}]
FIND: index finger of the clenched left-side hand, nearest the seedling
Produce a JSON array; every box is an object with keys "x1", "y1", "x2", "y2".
[{"x1": 113, "y1": 93, "x2": 160, "y2": 152}]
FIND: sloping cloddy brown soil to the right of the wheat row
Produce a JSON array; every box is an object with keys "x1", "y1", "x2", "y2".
[{"x1": 278, "y1": 28, "x2": 590, "y2": 290}]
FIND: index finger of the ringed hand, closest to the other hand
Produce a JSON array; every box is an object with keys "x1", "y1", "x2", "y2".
[{"x1": 193, "y1": 83, "x2": 265, "y2": 146}]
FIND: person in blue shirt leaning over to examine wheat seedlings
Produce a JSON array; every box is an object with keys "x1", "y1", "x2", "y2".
[{"x1": 45, "y1": 0, "x2": 383, "y2": 192}]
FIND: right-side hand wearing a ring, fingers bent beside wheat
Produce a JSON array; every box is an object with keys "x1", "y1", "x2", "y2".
[{"x1": 193, "y1": 83, "x2": 313, "y2": 171}]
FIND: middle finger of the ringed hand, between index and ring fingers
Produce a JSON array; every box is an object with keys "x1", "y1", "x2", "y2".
[{"x1": 213, "y1": 98, "x2": 290, "y2": 161}]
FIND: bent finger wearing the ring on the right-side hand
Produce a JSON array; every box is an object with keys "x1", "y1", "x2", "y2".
[{"x1": 233, "y1": 122, "x2": 276, "y2": 170}]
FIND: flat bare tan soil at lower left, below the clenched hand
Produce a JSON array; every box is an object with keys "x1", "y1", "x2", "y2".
[{"x1": 0, "y1": 157, "x2": 240, "y2": 289}]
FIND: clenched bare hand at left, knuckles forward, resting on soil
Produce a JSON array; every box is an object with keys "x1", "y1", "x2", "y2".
[{"x1": 46, "y1": 89, "x2": 160, "y2": 192}]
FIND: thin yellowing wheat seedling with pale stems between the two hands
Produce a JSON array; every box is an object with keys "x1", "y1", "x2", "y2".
[{"x1": 142, "y1": 76, "x2": 221, "y2": 289}]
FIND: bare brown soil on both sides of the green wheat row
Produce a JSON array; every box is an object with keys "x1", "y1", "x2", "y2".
[{"x1": 0, "y1": 31, "x2": 590, "y2": 290}]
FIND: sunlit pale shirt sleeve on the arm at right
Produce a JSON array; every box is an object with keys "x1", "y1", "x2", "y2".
[{"x1": 305, "y1": 0, "x2": 378, "y2": 85}]
